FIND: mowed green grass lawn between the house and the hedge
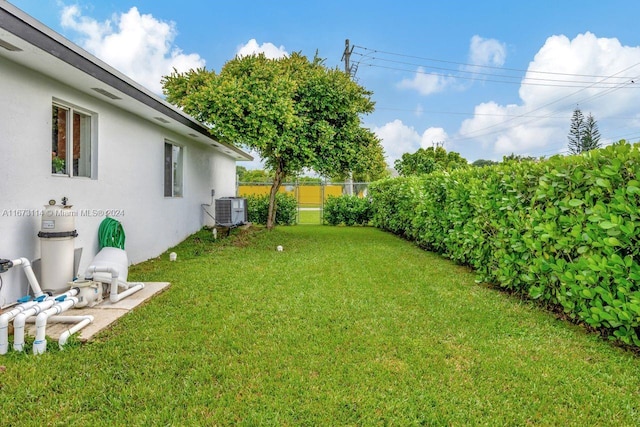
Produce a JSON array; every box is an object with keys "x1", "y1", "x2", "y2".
[{"x1": 0, "y1": 226, "x2": 640, "y2": 426}]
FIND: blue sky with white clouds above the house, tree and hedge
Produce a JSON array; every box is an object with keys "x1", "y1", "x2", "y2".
[{"x1": 10, "y1": 0, "x2": 640, "y2": 167}]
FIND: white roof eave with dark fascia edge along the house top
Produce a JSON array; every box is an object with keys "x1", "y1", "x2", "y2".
[{"x1": 0, "y1": 0, "x2": 253, "y2": 160}]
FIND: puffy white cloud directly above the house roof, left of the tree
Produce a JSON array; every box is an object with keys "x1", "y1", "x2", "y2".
[{"x1": 61, "y1": 6, "x2": 205, "y2": 94}]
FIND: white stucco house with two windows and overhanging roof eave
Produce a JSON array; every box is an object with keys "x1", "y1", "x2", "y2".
[{"x1": 0, "y1": 0, "x2": 252, "y2": 307}]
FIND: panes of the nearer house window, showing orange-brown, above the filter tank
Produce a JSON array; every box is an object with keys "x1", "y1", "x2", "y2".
[{"x1": 51, "y1": 103, "x2": 92, "y2": 178}]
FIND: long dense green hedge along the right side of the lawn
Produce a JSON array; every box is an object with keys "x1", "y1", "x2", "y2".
[{"x1": 370, "y1": 141, "x2": 640, "y2": 346}]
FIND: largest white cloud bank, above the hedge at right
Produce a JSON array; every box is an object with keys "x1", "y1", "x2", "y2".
[{"x1": 453, "y1": 32, "x2": 640, "y2": 159}]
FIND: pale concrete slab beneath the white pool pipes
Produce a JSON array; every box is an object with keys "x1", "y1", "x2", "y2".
[{"x1": 3, "y1": 282, "x2": 170, "y2": 342}]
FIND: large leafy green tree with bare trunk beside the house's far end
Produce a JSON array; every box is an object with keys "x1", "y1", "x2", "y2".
[{"x1": 162, "y1": 53, "x2": 379, "y2": 229}]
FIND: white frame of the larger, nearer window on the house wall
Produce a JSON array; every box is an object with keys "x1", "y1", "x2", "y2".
[{"x1": 51, "y1": 99, "x2": 97, "y2": 179}]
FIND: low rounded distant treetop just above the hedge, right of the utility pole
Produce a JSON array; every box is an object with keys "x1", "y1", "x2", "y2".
[{"x1": 394, "y1": 147, "x2": 469, "y2": 176}]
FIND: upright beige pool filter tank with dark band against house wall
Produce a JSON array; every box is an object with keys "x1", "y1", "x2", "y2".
[{"x1": 38, "y1": 199, "x2": 78, "y2": 294}]
